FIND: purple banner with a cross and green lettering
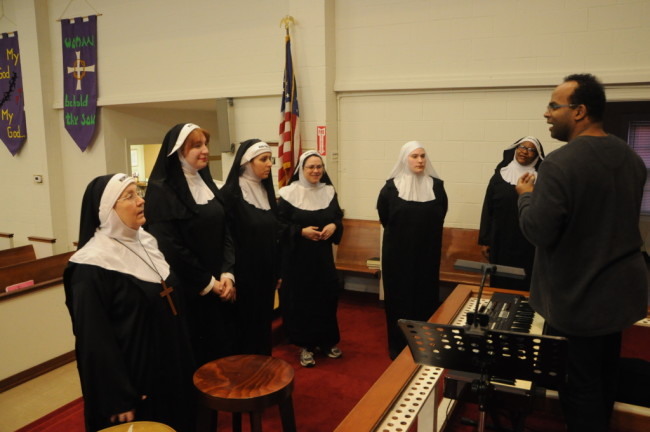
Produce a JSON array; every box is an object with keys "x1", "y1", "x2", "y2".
[{"x1": 61, "y1": 15, "x2": 97, "y2": 151}]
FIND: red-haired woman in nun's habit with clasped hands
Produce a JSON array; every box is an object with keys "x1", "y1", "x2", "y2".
[{"x1": 145, "y1": 123, "x2": 235, "y2": 365}]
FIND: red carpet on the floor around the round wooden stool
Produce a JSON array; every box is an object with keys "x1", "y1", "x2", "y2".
[{"x1": 17, "y1": 292, "x2": 650, "y2": 432}]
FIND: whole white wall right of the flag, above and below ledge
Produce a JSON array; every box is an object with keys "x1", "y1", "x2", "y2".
[{"x1": 335, "y1": 0, "x2": 650, "y2": 221}]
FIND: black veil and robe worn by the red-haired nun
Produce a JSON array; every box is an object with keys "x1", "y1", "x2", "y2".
[{"x1": 144, "y1": 124, "x2": 235, "y2": 365}]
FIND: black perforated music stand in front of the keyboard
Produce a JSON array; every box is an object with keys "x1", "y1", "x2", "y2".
[{"x1": 398, "y1": 319, "x2": 567, "y2": 432}]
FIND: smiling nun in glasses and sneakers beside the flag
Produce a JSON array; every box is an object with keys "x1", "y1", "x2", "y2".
[{"x1": 278, "y1": 150, "x2": 343, "y2": 367}]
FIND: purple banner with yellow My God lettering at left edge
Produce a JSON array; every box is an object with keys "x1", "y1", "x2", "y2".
[{"x1": 0, "y1": 32, "x2": 27, "y2": 156}]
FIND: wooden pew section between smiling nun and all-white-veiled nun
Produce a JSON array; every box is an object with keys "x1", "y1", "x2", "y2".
[{"x1": 335, "y1": 219, "x2": 381, "y2": 278}]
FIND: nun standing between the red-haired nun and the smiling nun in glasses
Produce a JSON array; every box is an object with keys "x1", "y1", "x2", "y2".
[{"x1": 222, "y1": 139, "x2": 280, "y2": 355}]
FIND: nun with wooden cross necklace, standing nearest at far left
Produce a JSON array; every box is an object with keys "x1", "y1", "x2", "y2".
[{"x1": 64, "y1": 174, "x2": 195, "y2": 431}]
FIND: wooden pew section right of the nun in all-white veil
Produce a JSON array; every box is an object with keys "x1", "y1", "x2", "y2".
[{"x1": 440, "y1": 227, "x2": 488, "y2": 286}]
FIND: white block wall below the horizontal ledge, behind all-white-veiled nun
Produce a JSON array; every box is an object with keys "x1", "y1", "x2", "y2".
[{"x1": 338, "y1": 86, "x2": 650, "y2": 223}]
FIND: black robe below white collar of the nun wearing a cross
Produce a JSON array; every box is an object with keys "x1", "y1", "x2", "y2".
[{"x1": 64, "y1": 264, "x2": 196, "y2": 432}]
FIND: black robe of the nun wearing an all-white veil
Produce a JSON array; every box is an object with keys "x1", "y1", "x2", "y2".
[{"x1": 377, "y1": 178, "x2": 447, "y2": 358}]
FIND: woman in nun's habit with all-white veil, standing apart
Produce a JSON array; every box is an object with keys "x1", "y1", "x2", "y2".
[{"x1": 377, "y1": 141, "x2": 447, "y2": 359}]
